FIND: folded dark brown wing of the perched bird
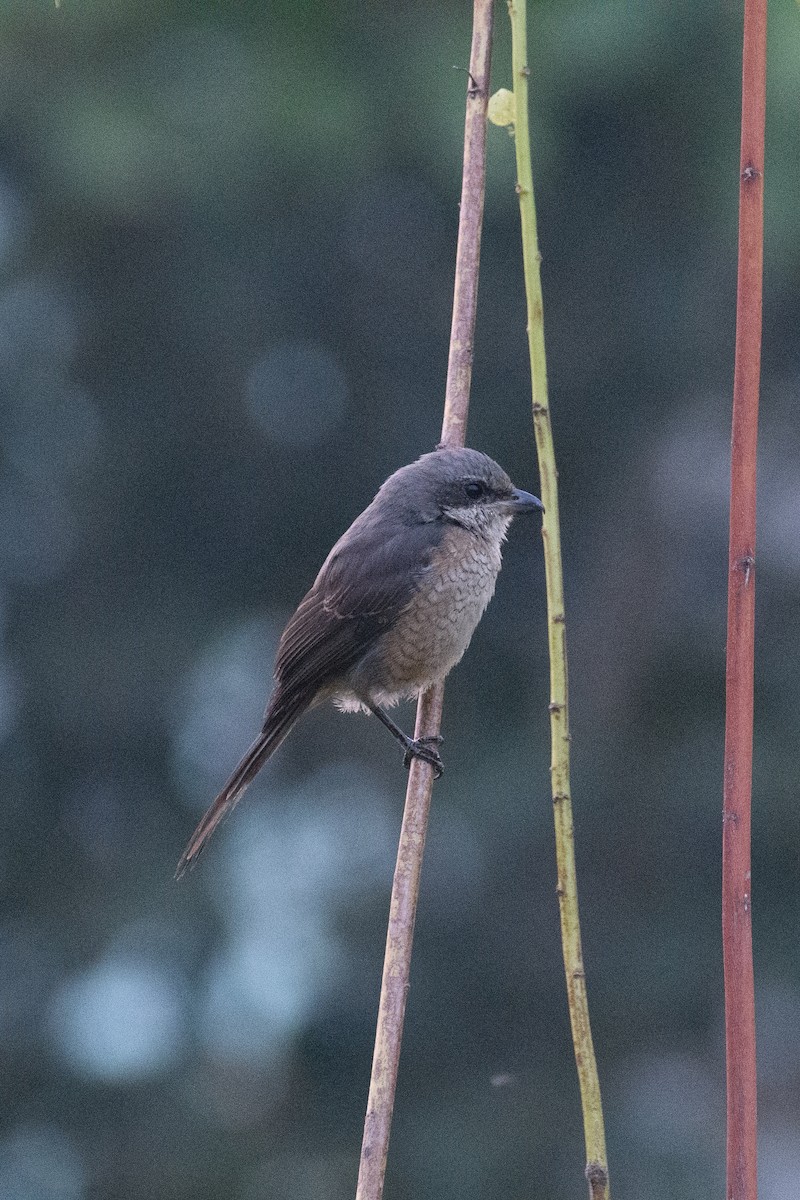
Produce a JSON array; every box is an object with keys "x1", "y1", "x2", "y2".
[{"x1": 275, "y1": 510, "x2": 439, "y2": 692}]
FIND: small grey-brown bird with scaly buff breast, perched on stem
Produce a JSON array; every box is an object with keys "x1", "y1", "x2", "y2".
[{"x1": 175, "y1": 445, "x2": 545, "y2": 877}]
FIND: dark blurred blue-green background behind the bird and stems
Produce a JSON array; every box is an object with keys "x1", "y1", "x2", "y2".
[{"x1": 0, "y1": 0, "x2": 800, "y2": 1200}]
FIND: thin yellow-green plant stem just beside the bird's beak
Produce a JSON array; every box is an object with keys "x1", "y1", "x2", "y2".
[{"x1": 509, "y1": 0, "x2": 609, "y2": 1200}]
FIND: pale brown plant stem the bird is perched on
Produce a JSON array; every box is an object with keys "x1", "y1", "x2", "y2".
[{"x1": 356, "y1": 0, "x2": 492, "y2": 1200}]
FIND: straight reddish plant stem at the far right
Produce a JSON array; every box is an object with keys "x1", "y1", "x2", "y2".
[{"x1": 722, "y1": 0, "x2": 766, "y2": 1200}]
